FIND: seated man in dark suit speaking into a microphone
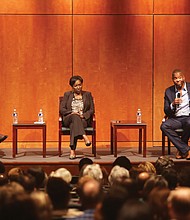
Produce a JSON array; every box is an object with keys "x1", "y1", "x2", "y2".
[{"x1": 160, "y1": 69, "x2": 190, "y2": 160}]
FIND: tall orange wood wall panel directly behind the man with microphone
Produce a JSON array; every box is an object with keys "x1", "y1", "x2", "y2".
[{"x1": 153, "y1": 16, "x2": 190, "y2": 141}]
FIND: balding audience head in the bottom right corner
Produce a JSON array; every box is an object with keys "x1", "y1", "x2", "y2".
[{"x1": 168, "y1": 187, "x2": 190, "y2": 220}]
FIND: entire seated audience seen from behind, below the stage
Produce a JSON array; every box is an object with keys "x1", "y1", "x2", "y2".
[{"x1": 0, "y1": 156, "x2": 190, "y2": 220}]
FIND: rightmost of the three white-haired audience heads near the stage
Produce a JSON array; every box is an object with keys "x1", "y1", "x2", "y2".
[{"x1": 108, "y1": 165, "x2": 129, "y2": 185}]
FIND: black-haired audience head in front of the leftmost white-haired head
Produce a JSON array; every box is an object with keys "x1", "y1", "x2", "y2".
[{"x1": 46, "y1": 177, "x2": 70, "y2": 210}]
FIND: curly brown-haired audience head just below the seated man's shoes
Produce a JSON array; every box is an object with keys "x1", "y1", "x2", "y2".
[{"x1": 155, "y1": 156, "x2": 174, "y2": 175}]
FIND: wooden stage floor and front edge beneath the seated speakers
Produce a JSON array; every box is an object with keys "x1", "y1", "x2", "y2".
[{"x1": 0, "y1": 144, "x2": 190, "y2": 175}]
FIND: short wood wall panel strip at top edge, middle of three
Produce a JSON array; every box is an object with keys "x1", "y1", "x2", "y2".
[{"x1": 73, "y1": 0, "x2": 153, "y2": 14}]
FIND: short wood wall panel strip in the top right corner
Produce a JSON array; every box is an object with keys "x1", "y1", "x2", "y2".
[{"x1": 154, "y1": 0, "x2": 190, "y2": 15}]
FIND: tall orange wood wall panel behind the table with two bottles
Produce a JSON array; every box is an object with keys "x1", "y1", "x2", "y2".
[{"x1": 0, "y1": 16, "x2": 72, "y2": 141}]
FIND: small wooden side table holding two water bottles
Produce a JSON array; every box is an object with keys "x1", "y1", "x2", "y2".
[{"x1": 12, "y1": 122, "x2": 46, "y2": 158}]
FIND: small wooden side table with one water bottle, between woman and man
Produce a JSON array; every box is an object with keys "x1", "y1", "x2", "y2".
[{"x1": 110, "y1": 120, "x2": 147, "y2": 157}]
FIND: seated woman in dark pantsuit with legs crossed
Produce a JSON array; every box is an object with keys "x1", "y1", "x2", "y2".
[{"x1": 59, "y1": 76, "x2": 94, "y2": 160}]
